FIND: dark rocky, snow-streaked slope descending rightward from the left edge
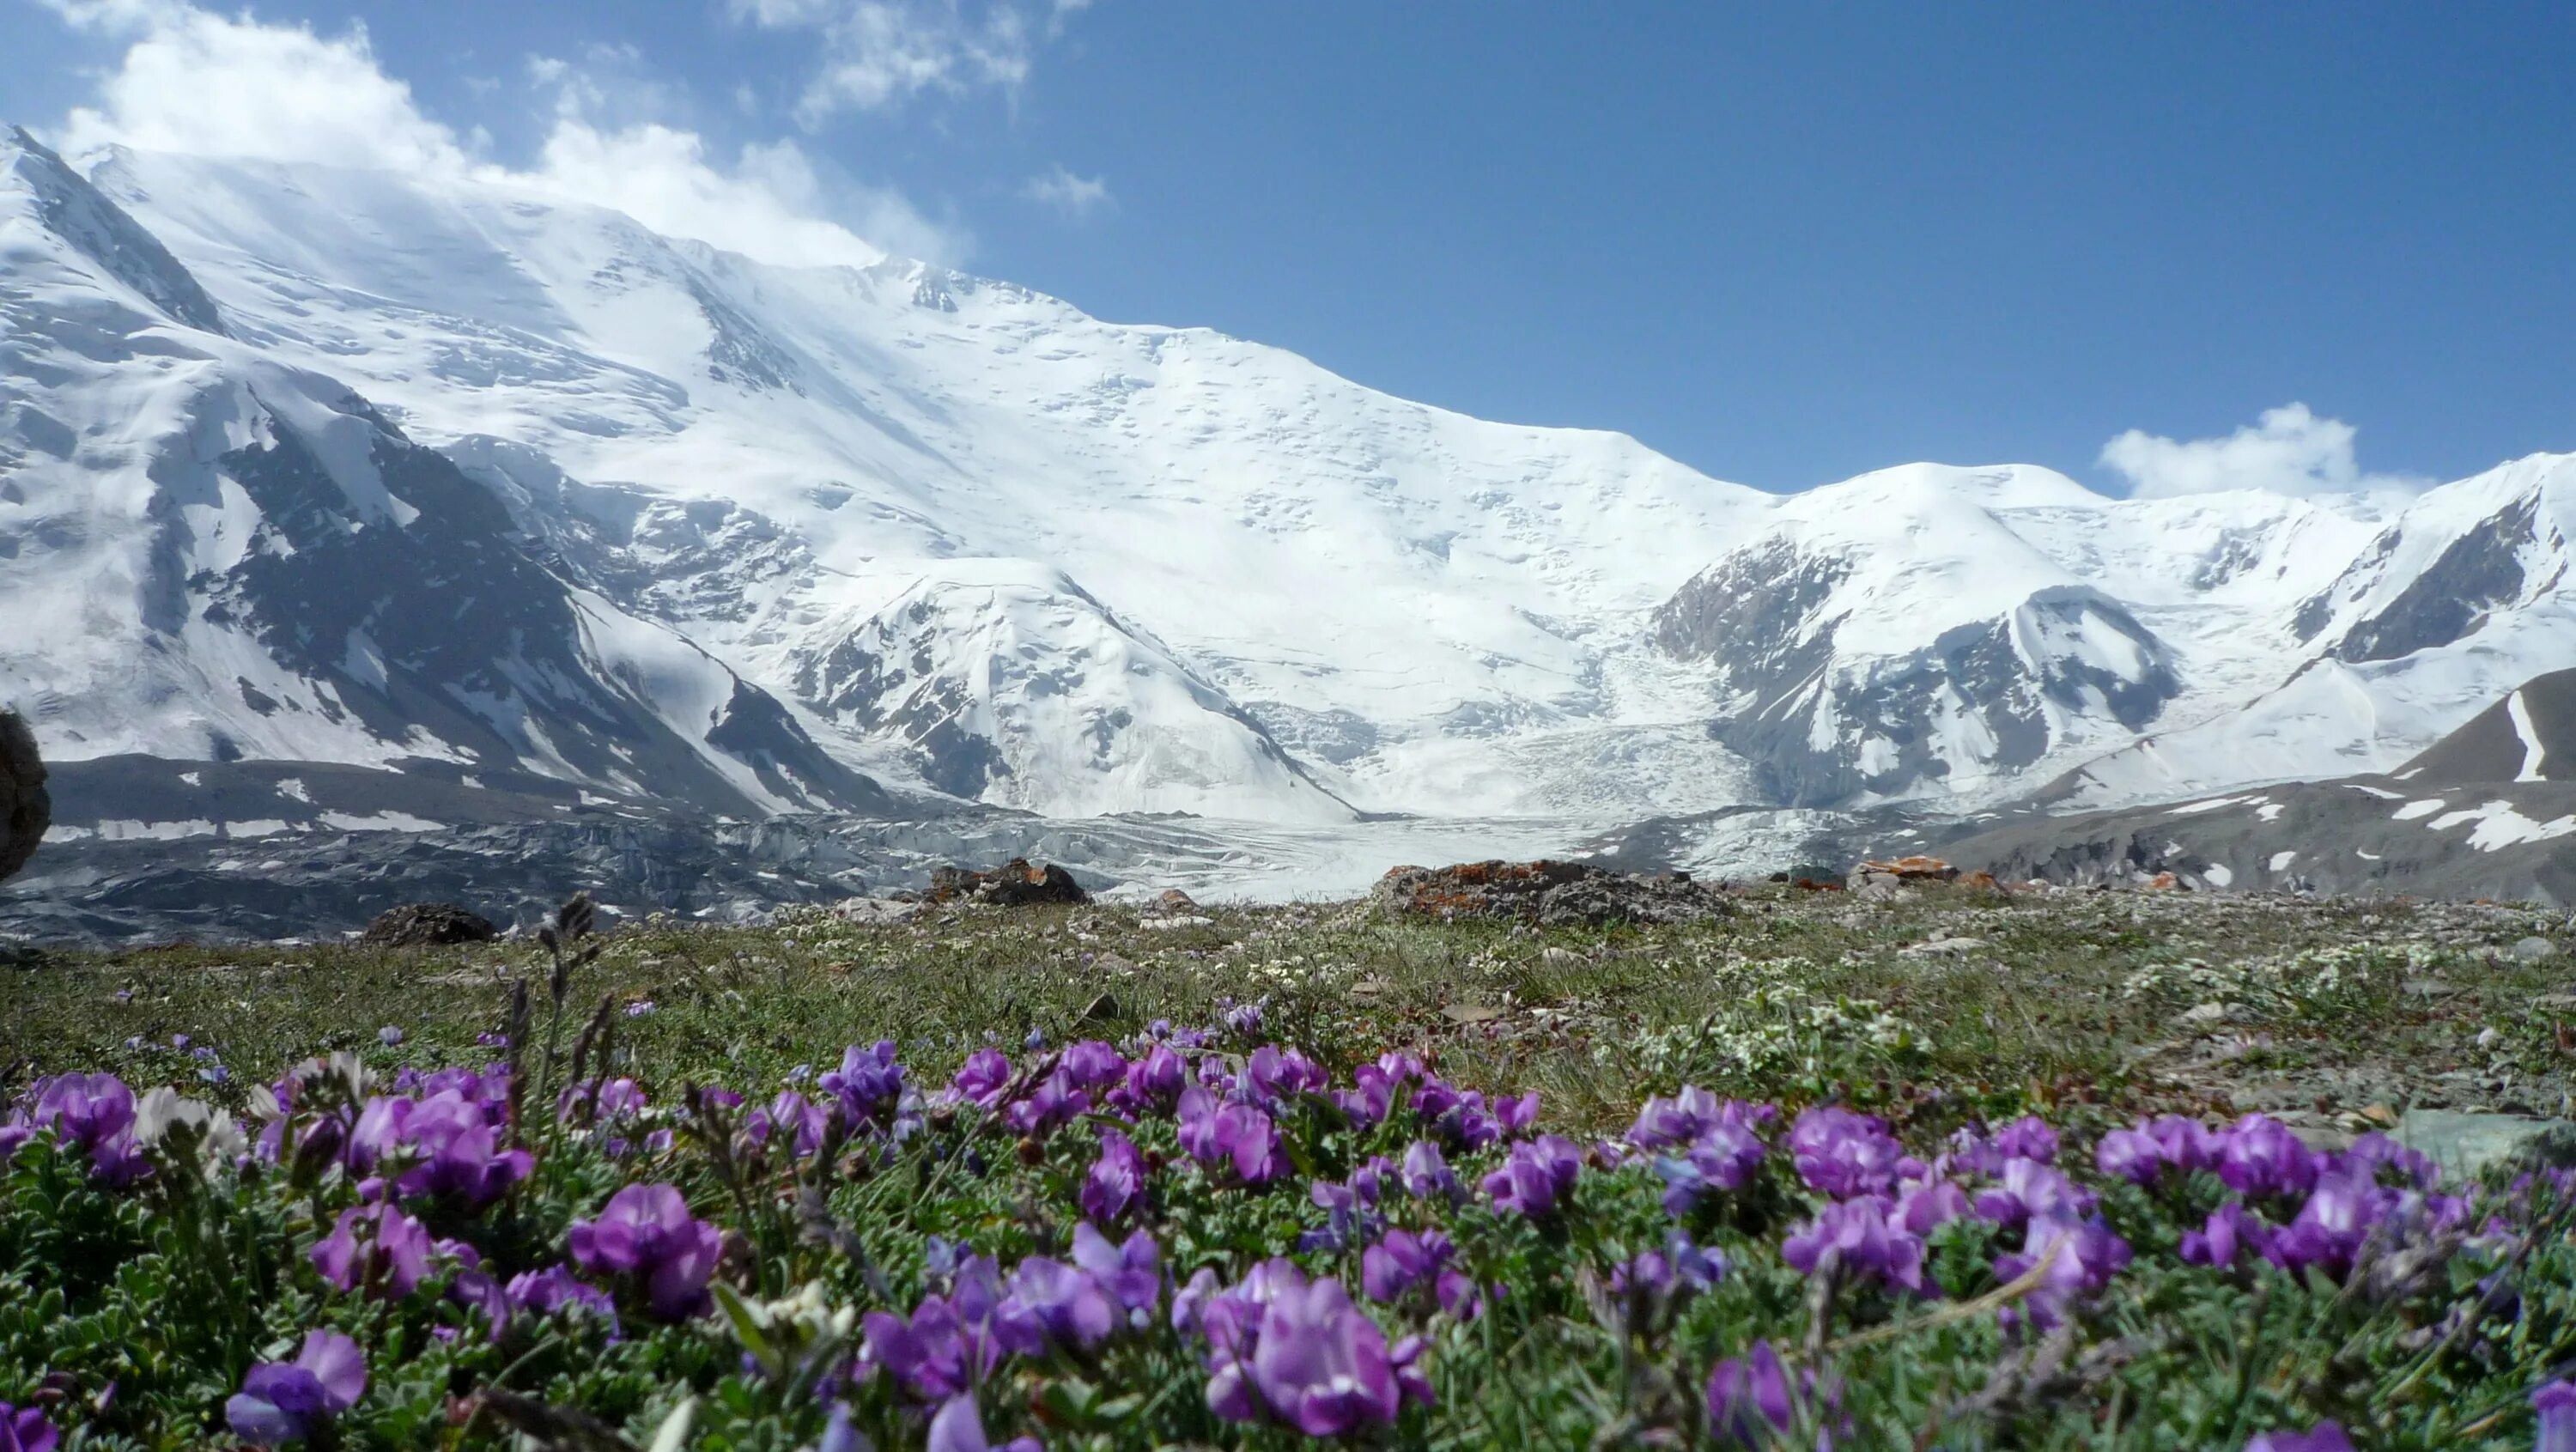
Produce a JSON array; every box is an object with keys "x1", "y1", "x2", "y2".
[{"x1": 0, "y1": 134, "x2": 886, "y2": 813}]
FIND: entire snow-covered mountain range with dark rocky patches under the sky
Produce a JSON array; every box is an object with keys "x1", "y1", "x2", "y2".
[{"x1": 0, "y1": 137, "x2": 2576, "y2": 826}]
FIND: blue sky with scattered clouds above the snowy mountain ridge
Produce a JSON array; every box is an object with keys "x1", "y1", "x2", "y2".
[{"x1": 0, "y1": 0, "x2": 2576, "y2": 489}]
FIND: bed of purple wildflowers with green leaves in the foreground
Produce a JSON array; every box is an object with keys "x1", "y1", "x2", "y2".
[{"x1": 0, "y1": 973, "x2": 2576, "y2": 1452}]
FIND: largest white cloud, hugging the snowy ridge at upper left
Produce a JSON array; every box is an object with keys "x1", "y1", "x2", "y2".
[{"x1": 49, "y1": 0, "x2": 969, "y2": 265}]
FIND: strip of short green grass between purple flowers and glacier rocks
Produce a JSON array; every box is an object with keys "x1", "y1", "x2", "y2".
[{"x1": 0, "y1": 888, "x2": 2571, "y2": 1130}]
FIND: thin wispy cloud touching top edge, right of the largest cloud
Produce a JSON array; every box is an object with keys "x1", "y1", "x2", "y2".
[{"x1": 732, "y1": 0, "x2": 1087, "y2": 126}]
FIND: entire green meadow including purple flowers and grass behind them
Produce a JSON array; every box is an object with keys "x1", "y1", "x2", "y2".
[{"x1": 0, "y1": 888, "x2": 2576, "y2": 1452}]
